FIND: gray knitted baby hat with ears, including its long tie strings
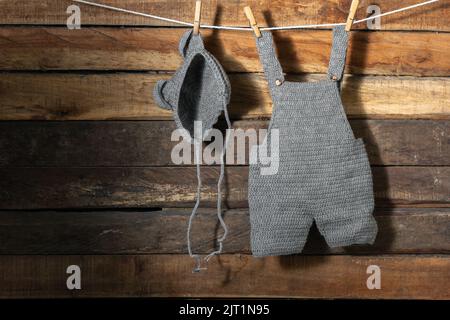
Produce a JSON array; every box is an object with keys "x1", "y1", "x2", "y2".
[{"x1": 153, "y1": 30, "x2": 231, "y2": 272}]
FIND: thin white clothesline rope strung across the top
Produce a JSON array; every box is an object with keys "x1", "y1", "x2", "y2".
[{"x1": 72, "y1": 0, "x2": 439, "y2": 31}]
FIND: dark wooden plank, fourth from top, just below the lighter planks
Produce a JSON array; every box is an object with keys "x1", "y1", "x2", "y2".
[{"x1": 0, "y1": 120, "x2": 450, "y2": 167}]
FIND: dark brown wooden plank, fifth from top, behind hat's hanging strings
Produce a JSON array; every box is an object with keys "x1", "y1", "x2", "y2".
[{"x1": 0, "y1": 166, "x2": 450, "y2": 209}]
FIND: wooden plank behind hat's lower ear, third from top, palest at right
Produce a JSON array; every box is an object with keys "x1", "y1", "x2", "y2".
[{"x1": 0, "y1": 72, "x2": 450, "y2": 120}]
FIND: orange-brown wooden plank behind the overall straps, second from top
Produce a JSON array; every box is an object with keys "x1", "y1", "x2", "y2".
[{"x1": 0, "y1": 27, "x2": 450, "y2": 76}]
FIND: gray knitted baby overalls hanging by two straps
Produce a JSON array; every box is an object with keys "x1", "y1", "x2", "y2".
[{"x1": 248, "y1": 26, "x2": 377, "y2": 256}]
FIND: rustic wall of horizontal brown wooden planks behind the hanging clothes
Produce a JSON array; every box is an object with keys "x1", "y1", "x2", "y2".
[{"x1": 0, "y1": 0, "x2": 450, "y2": 299}]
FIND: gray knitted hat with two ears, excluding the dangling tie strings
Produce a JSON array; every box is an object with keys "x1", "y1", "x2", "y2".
[{"x1": 154, "y1": 30, "x2": 231, "y2": 139}]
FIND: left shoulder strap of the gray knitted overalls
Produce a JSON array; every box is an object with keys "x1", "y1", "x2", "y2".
[{"x1": 256, "y1": 31, "x2": 284, "y2": 88}]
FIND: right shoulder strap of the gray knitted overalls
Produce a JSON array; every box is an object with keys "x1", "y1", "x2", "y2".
[{"x1": 328, "y1": 26, "x2": 348, "y2": 81}]
